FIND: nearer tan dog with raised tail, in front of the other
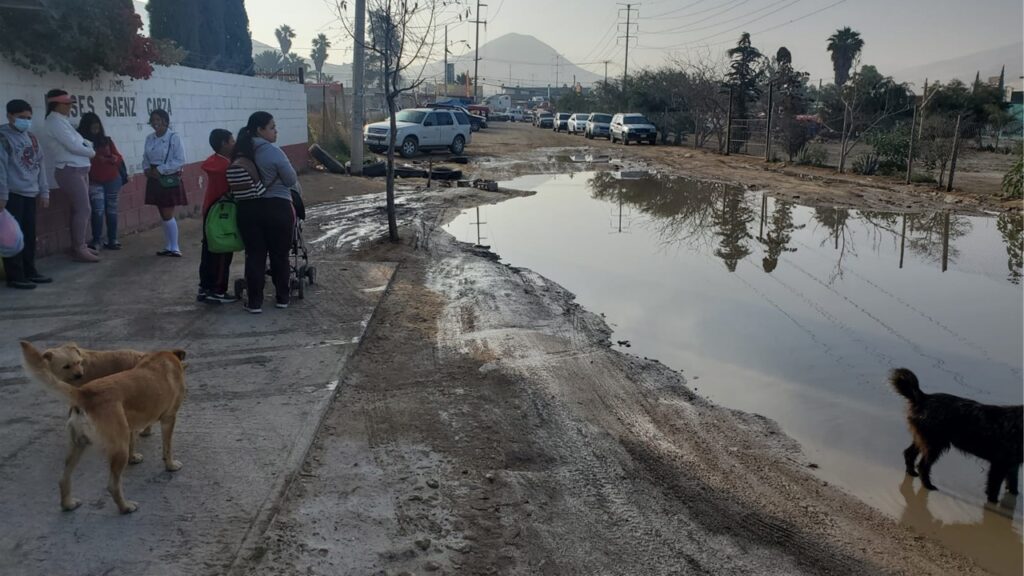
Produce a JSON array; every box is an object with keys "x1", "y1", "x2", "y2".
[{"x1": 22, "y1": 341, "x2": 185, "y2": 513}]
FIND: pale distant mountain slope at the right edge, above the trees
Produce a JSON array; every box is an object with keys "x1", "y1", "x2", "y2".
[{"x1": 892, "y1": 42, "x2": 1024, "y2": 89}]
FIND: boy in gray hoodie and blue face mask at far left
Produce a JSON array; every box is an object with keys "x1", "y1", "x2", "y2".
[{"x1": 0, "y1": 99, "x2": 50, "y2": 290}]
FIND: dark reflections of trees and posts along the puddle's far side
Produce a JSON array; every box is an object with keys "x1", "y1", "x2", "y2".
[{"x1": 589, "y1": 172, "x2": 1011, "y2": 284}]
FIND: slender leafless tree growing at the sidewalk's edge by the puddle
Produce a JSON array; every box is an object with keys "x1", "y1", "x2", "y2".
[{"x1": 334, "y1": 0, "x2": 462, "y2": 242}]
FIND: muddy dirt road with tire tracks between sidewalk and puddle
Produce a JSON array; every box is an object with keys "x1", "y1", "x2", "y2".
[{"x1": 236, "y1": 123, "x2": 999, "y2": 575}]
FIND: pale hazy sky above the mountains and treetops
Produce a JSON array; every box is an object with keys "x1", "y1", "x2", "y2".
[{"x1": 246, "y1": 0, "x2": 1024, "y2": 86}]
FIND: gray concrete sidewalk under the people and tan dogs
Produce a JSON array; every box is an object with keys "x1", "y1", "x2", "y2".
[{"x1": 0, "y1": 212, "x2": 395, "y2": 575}]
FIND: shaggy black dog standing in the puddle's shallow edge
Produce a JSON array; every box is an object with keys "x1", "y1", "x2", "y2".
[{"x1": 889, "y1": 368, "x2": 1024, "y2": 502}]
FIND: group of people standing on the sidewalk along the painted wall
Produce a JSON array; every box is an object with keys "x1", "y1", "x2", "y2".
[{"x1": 0, "y1": 89, "x2": 298, "y2": 314}]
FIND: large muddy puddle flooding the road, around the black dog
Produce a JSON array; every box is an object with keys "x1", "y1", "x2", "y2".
[{"x1": 447, "y1": 172, "x2": 1024, "y2": 574}]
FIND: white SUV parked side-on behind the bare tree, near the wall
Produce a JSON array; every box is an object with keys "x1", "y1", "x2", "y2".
[{"x1": 362, "y1": 108, "x2": 471, "y2": 158}]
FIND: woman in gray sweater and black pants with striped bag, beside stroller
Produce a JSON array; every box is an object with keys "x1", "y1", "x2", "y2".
[{"x1": 234, "y1": 112, "x2": 298, "y2": 314}]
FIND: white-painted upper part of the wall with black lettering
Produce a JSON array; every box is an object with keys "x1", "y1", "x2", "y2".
[{"x1": 0, "y1": 58, "x2": 307, "y2": 173}]
